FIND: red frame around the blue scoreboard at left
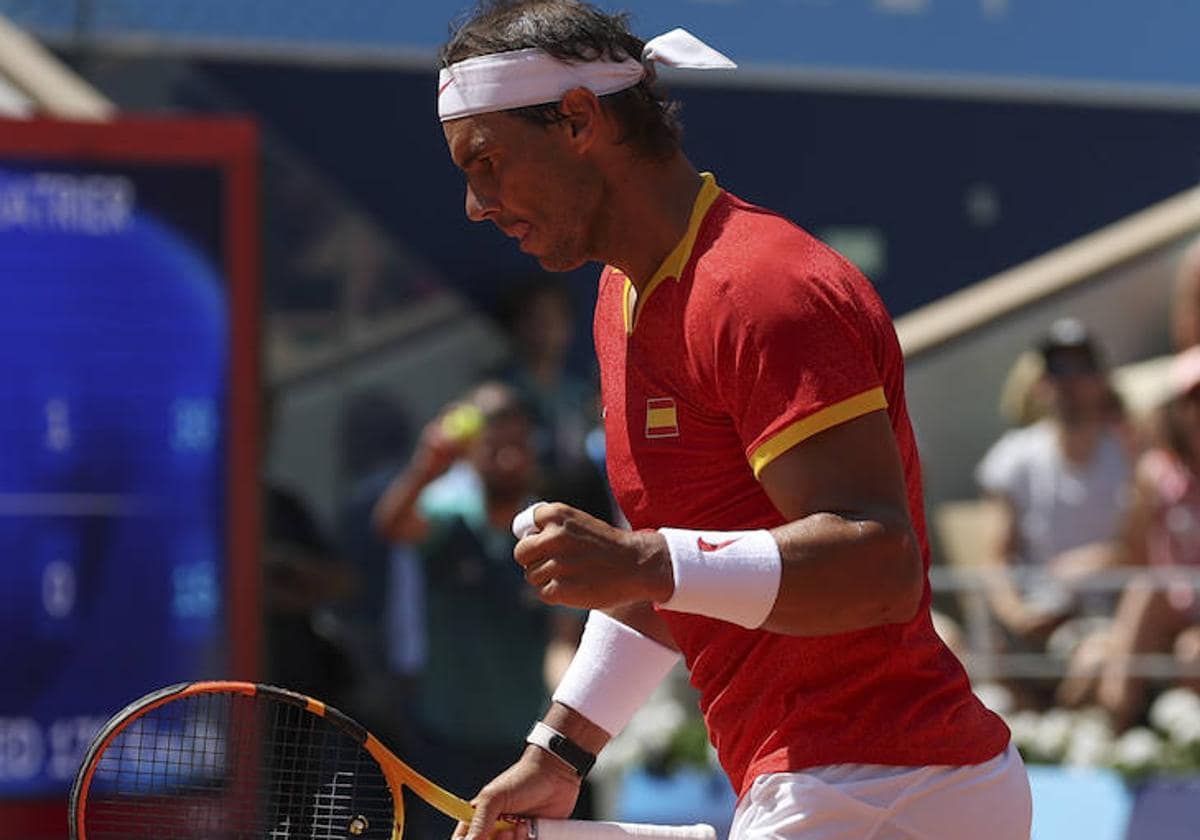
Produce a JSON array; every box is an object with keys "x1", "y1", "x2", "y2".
[{"x1": 0, "y1": 118, "x2": 262, "y2": 840}]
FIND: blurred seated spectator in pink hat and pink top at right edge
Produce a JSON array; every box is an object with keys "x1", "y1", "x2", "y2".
[{"x1": 1097, "y1": 346, "x2": 1200, "y2": 728}]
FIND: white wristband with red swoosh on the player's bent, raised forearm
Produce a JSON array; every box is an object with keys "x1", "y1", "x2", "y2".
[{"x1": 659, "y1": 528, "x2": 784, "y2": 629}]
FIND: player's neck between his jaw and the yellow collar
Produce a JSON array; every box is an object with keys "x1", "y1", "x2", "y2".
[{"x1": 598, "y1": 154, "x2": 702, "y2": 292}]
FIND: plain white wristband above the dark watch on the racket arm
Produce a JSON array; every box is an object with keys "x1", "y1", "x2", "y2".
[{"x1": 553, "y1": 610, "x2": 680, "y2": 736}]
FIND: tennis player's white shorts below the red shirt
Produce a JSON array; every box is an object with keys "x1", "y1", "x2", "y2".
[{"x1": 730, "y1": 744, "x2": 1033, "y2": 840}]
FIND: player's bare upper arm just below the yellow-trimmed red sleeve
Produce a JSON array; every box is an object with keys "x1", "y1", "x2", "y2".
[{"x1": 758, "y1": 410, "x2": 911, "y2": 524}]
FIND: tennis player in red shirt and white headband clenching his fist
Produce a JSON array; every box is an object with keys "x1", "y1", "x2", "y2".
[{"x1": 438, "y1": 0, "x2": 1031, "y2": 840}]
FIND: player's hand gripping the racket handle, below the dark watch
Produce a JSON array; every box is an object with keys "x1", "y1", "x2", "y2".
[{"x1": 454, "y1": 745, "x2": 581, "y2": 840}]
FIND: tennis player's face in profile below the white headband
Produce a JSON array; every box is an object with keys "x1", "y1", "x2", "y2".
[{"x1": 443, "y1": 113, "x2": 600, "y2": 271}]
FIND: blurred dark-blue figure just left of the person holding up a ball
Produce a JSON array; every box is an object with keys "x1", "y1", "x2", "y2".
[{"x1": 338, "y1": 390, "x2": 425, "y2": 751}]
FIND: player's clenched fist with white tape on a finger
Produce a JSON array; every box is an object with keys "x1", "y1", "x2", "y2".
[{"x1": 514, "y1": 503, "x2": 674, "y2": 610}]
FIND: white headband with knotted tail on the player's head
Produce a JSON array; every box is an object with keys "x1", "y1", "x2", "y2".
[{"x1": 438, "y1": 29, "x2": 737, "y2": 122}]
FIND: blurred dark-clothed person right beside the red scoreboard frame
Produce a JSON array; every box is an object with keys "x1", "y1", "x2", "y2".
[{"x1": 263, "y1": 484, "x2": 355, "y2": 706}]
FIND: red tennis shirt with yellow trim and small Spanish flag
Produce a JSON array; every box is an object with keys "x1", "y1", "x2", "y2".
[{"x1": 595, "y1": 175, "x2": 1009, "y2": 793}]
